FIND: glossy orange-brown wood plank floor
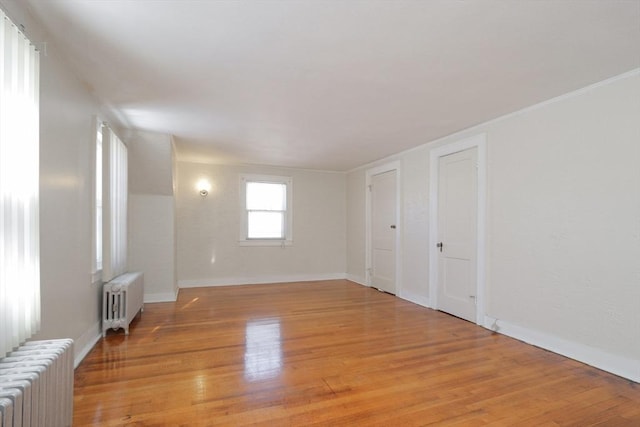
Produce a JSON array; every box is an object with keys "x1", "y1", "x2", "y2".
[{"x1": 74, "y1": 280, "x2": 640, "y2": 427}]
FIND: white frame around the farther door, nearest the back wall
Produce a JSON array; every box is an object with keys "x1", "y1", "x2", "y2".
[{"x1": 365, "y1": 160, "x2": 402, "y2": 296}]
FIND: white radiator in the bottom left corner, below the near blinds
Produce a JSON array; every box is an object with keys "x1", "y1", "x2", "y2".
[{"x1": 0, "y1": 339, "x2": 73, "y2": 427}]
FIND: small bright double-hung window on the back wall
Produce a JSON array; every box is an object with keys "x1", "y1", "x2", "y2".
[{"x1": 240, "y1": 175, "x2": 292, "y2": 246}]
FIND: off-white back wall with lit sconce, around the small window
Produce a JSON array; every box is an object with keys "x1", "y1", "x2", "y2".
[{"x1": 176, "y1": 162, "x2": 346, "y2": 287}]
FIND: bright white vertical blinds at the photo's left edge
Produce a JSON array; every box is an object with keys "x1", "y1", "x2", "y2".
[{"x1": 0, "y1": 10, "x2": 40, "y2": 358}]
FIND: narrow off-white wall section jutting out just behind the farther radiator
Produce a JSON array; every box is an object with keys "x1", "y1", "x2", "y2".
[{"x1": 128, "y1": 131, "x2": 177, "y2": 302}]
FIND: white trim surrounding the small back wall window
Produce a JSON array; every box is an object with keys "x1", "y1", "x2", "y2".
[{"x1": 238, "y1": 174, "x2": 293, "y2": 247}]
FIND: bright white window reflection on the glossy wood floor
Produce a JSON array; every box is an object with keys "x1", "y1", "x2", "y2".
[{"x1": 244, "y1": 319, "x2": 282, "y2": 381}]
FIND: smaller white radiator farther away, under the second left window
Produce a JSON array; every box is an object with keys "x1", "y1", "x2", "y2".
[{"x1": 102, "y1": 272, "x2": 144, "y2": 337}]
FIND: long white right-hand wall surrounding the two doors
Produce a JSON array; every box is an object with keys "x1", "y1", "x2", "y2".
[{"x1": 348, "y1": 72, "x2": 640, "y2": 381}]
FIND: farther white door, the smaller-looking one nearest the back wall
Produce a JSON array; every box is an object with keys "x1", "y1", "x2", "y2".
[{"x1": 371, "y1": 170, "x2": 397, "y2": 294}]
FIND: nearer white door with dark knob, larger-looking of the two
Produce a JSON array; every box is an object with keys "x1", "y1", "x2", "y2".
[{"x1": 435, "y1": 147, "x2": 478, "y2": 323}]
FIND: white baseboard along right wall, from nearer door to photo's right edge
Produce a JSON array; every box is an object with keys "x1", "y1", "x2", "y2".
[{"x1": 484, "y1": 316, "x2": 640, "y2": 383}]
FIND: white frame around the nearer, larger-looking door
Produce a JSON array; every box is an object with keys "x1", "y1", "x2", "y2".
[{"x1": 428, "y1": 133, "x2": 487, "y2": 325}]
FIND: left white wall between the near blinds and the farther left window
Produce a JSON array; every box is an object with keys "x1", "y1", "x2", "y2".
[{"x1": 0, "y1": 1, "x2": 109, "y2": 361}]
